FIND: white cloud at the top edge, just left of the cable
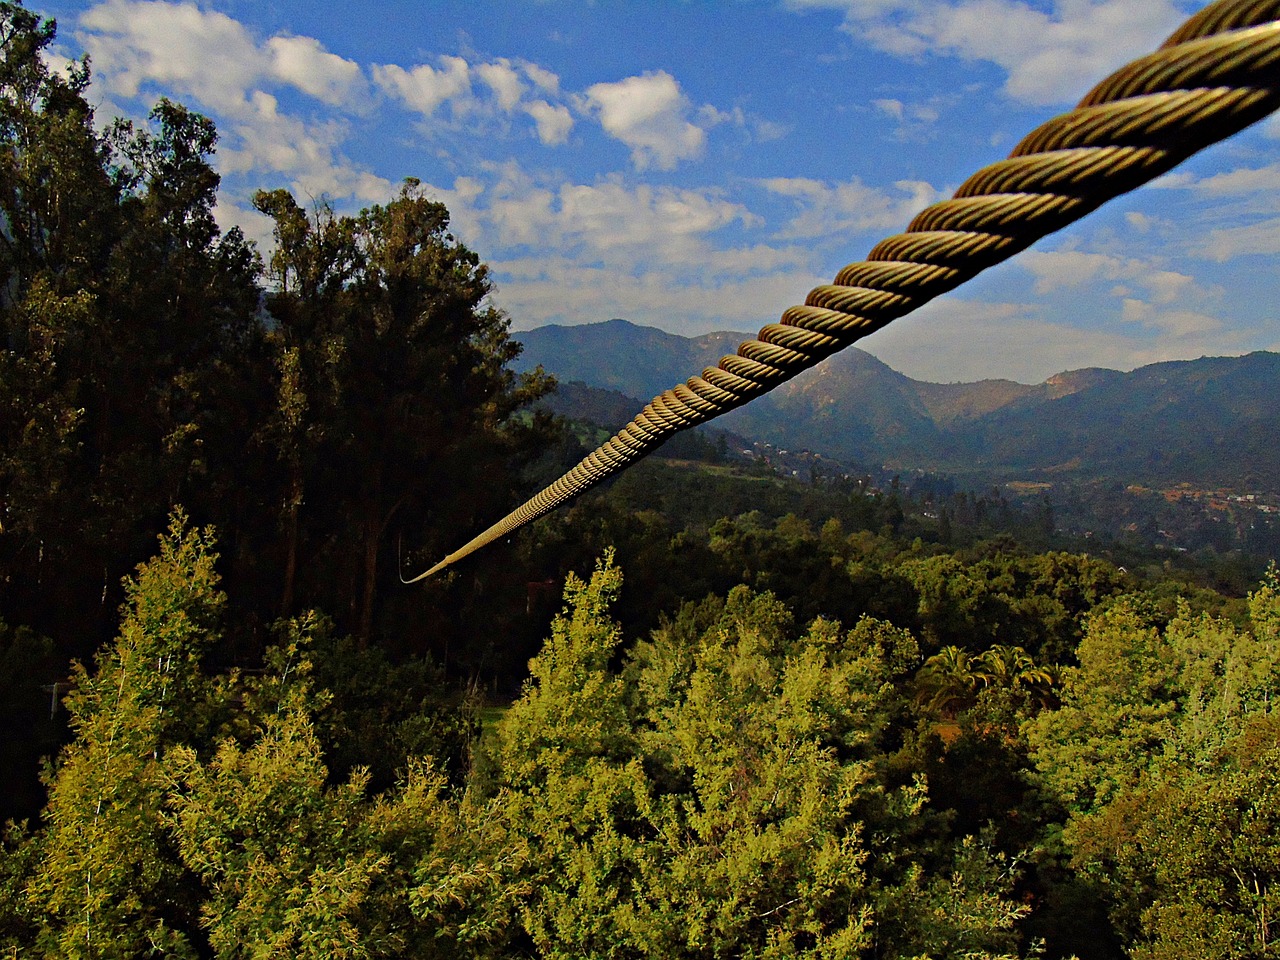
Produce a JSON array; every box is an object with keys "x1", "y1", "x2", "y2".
[{"x1": 788, "y1": 0, "x2": 1185, "y2": 105}]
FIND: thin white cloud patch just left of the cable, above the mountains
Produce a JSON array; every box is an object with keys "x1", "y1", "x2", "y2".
[{"x1": 759, "y1": 177, "x2": 942, "y2": 239}]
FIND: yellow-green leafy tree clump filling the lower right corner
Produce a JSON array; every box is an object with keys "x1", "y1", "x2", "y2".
[{"x1": 1027, "y1": 567, "x2": 1280, "y2": 960}]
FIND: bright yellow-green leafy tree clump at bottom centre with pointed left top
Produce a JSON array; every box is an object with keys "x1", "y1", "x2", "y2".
[{"x1": 424, "y1": 554, "x2": 1027, "y2": 960}]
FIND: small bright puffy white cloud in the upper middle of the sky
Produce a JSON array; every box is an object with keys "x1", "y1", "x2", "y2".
[{"x1": 586, "y1": 70, "x2": 707, "y2": 170}]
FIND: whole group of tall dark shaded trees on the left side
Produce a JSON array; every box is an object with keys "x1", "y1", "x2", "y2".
[{"x1": 0, "y1": 3, "x2": 550, "y2": 657}]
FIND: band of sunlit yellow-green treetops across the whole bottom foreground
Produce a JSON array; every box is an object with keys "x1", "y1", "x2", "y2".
[{"x1": 0, "y1": 516, "x2": 1280, "y2": 957}]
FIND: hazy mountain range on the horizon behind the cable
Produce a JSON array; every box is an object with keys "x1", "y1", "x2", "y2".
[{"x1": 516, "y1": 320, "x2": 1280, "y2": 493}]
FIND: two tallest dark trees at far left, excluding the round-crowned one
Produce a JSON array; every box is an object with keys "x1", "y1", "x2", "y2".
[{"x1": 0, "y1": 3, "x2": 265, "y2": 653}]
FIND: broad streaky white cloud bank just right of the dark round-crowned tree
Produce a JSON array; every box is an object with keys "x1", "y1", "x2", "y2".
[{"x1": 440, "y1": 163, "x2": 819, "y2": 334}]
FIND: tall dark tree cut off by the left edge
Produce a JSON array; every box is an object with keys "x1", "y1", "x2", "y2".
[{"x1": 0, "y1": 3, "x2": 114, "y2": 624}]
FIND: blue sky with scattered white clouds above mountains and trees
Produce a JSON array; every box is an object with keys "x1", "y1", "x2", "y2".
[{"x1": 37, "y1": 0, "x2": 1280, "y2": 383}]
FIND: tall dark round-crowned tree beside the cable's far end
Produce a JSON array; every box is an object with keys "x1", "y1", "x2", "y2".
[{"x1": 255, "y1": 180, "x2": 550, "y2": 641}]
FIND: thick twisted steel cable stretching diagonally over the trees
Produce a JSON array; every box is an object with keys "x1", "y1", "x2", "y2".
[{"x1": 406, "y1": 0, "x2": 1280, "y2": 584}]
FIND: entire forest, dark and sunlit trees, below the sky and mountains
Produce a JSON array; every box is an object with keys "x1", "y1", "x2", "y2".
[{"x1": 0, "y1": 3, "x2": 1280, "y2": 960}]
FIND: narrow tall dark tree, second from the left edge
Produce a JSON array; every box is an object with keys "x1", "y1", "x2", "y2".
[{"x1": 98, "y1": 100, "x2": 268, "y2": 576}]
